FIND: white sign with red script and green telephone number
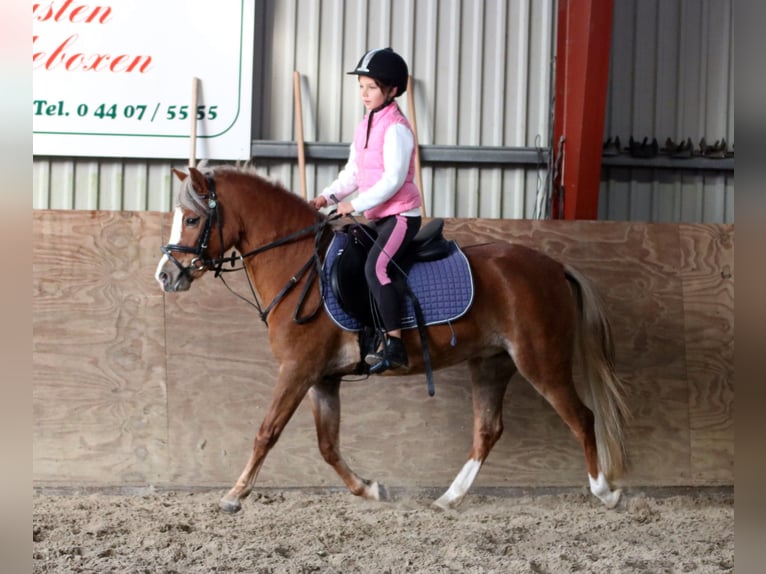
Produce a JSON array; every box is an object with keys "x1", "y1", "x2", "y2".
[{"x1": 32, "y1": 0, "x2": 255, "y2": 160}]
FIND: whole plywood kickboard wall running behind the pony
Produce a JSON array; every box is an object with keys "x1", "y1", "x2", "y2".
[{"x1": 34, "y1": 212, "x2": 733, "y2": 487}]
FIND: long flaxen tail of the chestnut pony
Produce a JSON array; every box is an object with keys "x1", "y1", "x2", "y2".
[{"x1": 564, "y1": 265, "x2": 629, "y2": 480}]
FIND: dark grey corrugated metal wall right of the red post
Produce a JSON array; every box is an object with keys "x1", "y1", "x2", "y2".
[{"x1": 599, "y1": 0, "x2": 734, "y2": 223}]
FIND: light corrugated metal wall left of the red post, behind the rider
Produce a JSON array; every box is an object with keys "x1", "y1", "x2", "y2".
[{"x1": 34, "y1": 0, "x2": 555, "y2": 218}]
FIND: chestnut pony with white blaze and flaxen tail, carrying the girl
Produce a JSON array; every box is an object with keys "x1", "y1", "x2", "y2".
[{"x1": 155, "y1": 166, "x2": 627, "y2": 512}]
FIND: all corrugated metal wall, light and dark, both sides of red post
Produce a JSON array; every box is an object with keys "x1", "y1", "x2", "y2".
[{"x1": 33, "y1": 0, "x2": 734, "y2": 223}]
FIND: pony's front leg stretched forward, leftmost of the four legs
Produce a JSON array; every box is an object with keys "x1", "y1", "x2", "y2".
[{"x1": 219, "y1": 363, "x2": 313, "y2": 512}]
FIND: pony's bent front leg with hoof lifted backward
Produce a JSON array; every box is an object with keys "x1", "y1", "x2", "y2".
[{"x1": 309, "y1": 379, "x2": 388, "y2": 500}]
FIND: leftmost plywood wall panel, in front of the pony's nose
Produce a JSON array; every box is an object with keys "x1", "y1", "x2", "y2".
[{"x1": 32, "y1": 211, "x2": 167, "y2": 484}]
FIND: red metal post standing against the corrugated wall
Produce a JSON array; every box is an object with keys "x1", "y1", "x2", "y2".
[{"x1": 552, "y1": 0, "x2": 614, "y2": 219}]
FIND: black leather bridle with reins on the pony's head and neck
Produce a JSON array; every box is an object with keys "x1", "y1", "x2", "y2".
[{"x1": 160, "y1": 175, "x2": 338, "y2": 325}]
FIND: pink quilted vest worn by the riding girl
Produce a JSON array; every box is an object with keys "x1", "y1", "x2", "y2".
[{"x1": 354, "y1": 104, "x2": 420, "y2": 219}]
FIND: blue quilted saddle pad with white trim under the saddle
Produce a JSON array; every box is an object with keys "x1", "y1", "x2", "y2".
[{"x1": 322, "y1": 232, "x2": 473, "y2": 331}]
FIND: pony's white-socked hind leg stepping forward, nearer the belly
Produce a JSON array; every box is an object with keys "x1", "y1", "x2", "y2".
[{"x1": 433, "y1": 354, "x2": 516, "y2": 509}]
